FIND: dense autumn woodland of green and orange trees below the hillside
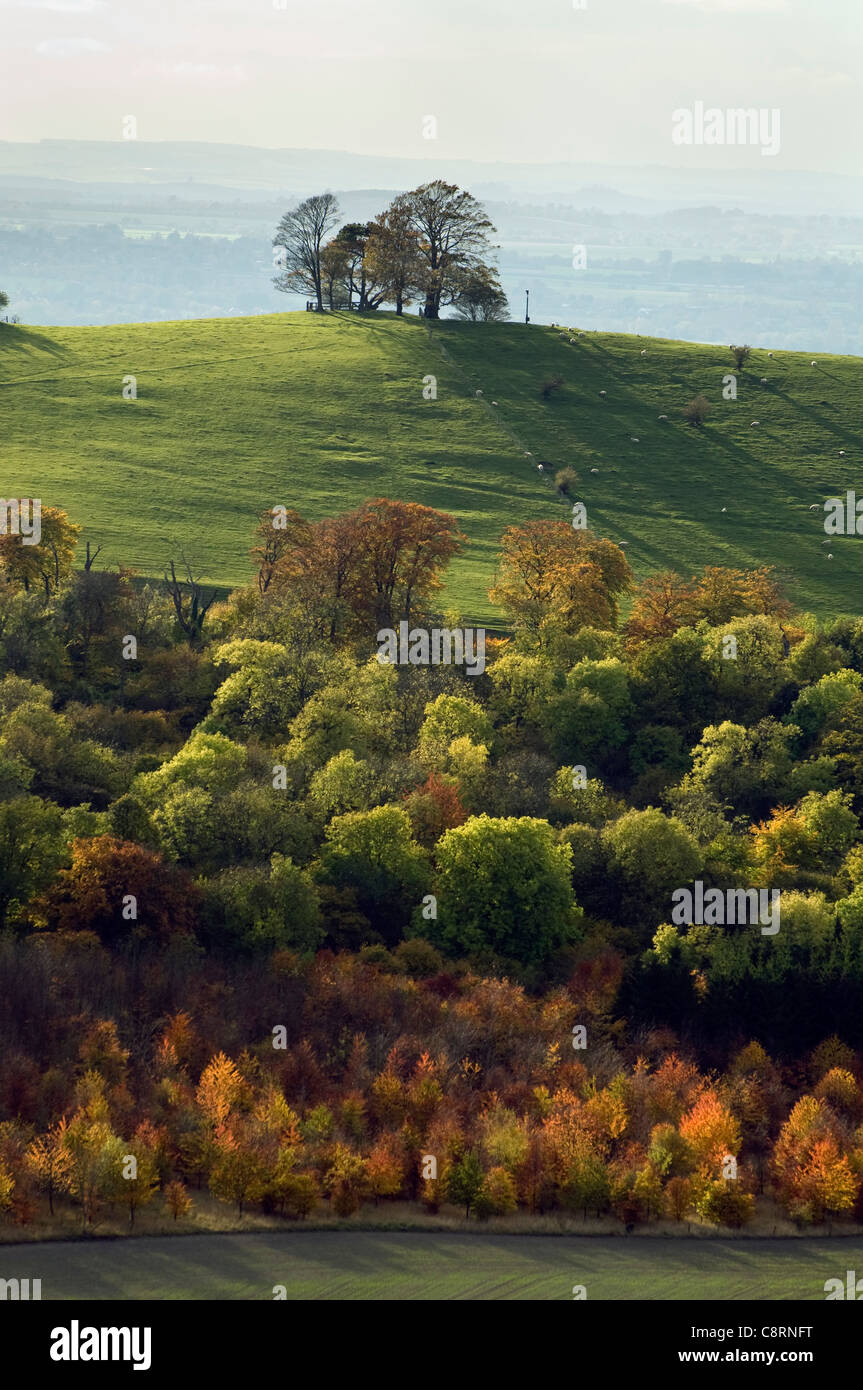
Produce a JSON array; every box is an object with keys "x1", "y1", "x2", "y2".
[{"x1": 0, "y1": 499, "x2": 863, "y2": 1222}]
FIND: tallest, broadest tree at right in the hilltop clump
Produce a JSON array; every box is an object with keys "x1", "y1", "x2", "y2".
[{"x1": 404, "y1": 179, "x2": 495, "y2": 318}]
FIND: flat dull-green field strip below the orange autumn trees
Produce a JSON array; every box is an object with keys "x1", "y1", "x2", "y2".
[{"x1": 0, "y1": 1232, "x2": 863, "y2": 1301}]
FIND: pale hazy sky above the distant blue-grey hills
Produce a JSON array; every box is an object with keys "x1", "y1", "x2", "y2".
[{"x1": 0, "y1": 0, "x2": 863, "y2": 174}]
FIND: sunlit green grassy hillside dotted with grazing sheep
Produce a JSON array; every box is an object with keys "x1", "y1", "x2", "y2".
[{"x1": 0, "y1": 313, "x2": 863, "y2": 623}]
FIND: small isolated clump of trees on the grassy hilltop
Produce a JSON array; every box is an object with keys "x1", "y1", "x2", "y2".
[{"x1": 272, "y1": 179, "x2": 509, "y2": 321}]
